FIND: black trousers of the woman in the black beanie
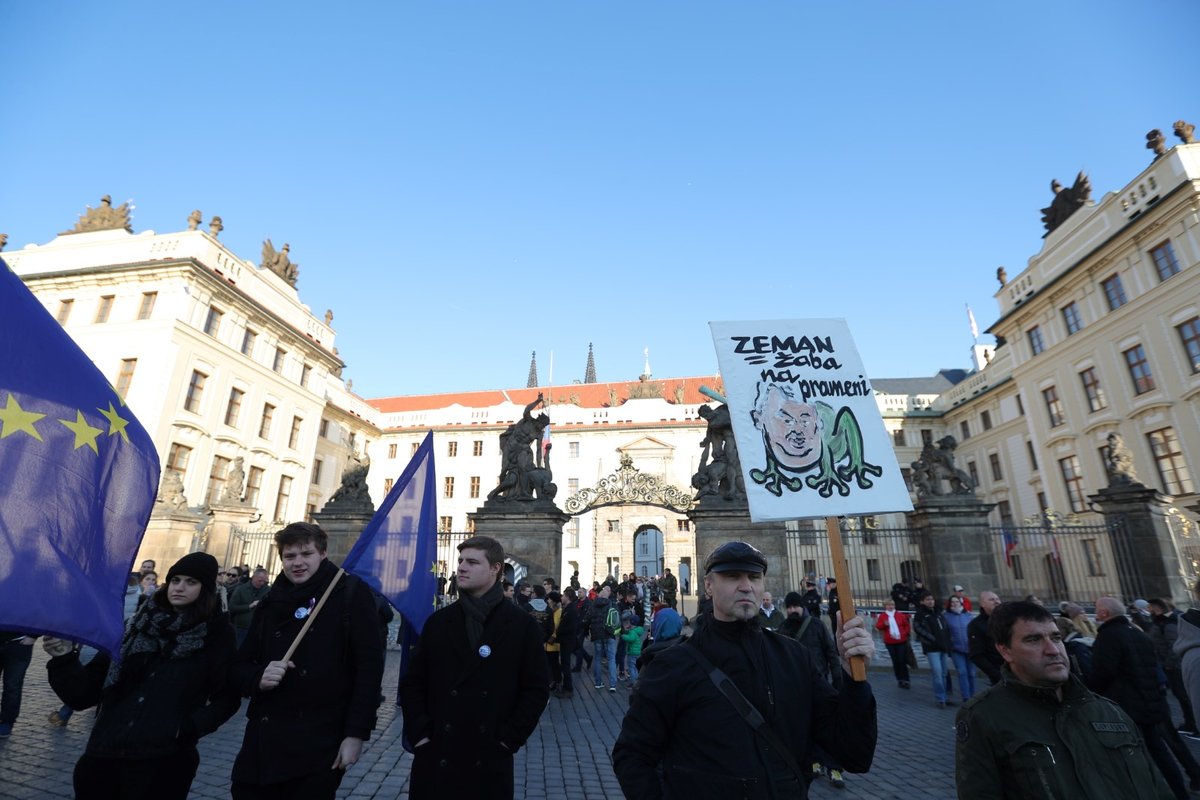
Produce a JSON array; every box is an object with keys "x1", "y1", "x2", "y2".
[{"x1": 73, "y1": 747, "x2": 200, "y2": 800}]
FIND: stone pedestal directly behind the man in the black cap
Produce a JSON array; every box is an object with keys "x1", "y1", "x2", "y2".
[{"x1": 688, "y1": 503, "x2": 797, "y2": 602}]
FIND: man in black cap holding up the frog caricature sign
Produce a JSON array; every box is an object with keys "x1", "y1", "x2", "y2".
[{"x1": 612, "y1": 542, "x2": 876, "y2": 800}]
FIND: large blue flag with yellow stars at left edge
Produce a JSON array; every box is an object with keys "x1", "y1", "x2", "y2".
[{"x1": 0, "y1": 260, "x2": 158, "y2": 654}]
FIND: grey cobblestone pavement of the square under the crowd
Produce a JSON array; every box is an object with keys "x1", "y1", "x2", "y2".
[{"x1": 7, "y1": 646, "x2": 1200, "y2": 800}]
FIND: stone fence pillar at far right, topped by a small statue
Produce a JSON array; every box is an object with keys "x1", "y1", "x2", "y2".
[{"x1": 1087, "y1": 482, "x2": 1192, "y2": 606}]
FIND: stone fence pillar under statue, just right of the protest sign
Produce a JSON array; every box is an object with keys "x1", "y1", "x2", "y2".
[{"x1": 908, "y1": 494, "x2": 1000, "y2": 597}]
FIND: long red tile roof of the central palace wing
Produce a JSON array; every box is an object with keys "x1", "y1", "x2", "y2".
[{"x1": 367, "y1": 375, "x2": 724, "y2": 414}]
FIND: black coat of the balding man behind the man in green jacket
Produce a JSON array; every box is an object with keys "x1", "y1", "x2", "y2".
[{"x1": 1087, "y1": 616, "x2": 1168, "y2": 724}]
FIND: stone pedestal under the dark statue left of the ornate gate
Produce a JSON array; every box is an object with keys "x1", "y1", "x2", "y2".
[{"x1": 467, "y1": 500, "x2": 571, "y2": 585}]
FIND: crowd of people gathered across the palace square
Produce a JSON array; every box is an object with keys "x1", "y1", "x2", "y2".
[{"x1": 11, "y1": 532, "x2": 1200, "y2": 800}]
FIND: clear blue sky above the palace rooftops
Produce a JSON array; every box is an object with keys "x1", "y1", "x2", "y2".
[{"x1": 0, "y1": 0, "x2": 1200, "y2": 397}]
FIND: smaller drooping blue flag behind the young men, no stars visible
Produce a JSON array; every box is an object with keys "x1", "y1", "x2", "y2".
[{"x1": 342, "y1": 431, "x2": 438, "y2": 633}]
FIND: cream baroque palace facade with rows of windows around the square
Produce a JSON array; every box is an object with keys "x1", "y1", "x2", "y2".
[{"x1": 4, "y1": 130, "x2": 1200, "y2": 589}]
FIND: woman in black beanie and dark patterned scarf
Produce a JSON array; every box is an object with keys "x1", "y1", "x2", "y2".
[{"x1": 43, "y1": 553, "x2": 240, "y2": 800}]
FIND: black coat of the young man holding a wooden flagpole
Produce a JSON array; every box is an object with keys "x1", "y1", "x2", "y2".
[{"x1": 232, "y1": 560, "x2": 384, "y2": 784}]
